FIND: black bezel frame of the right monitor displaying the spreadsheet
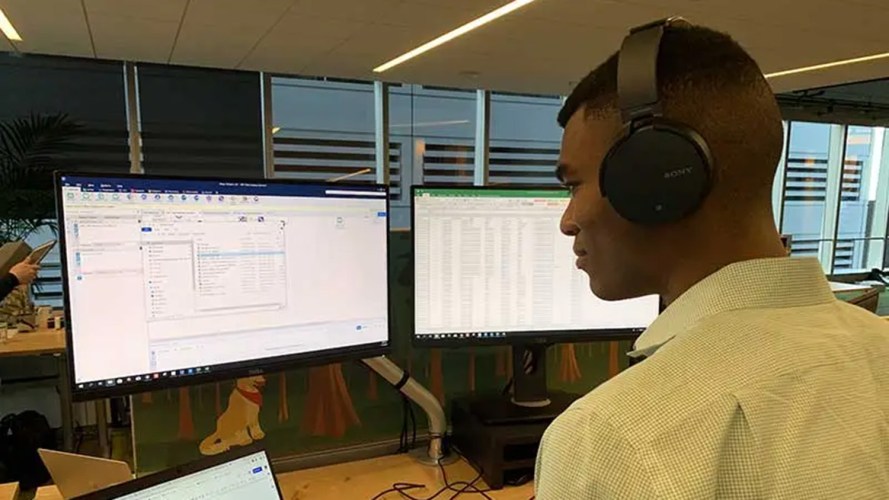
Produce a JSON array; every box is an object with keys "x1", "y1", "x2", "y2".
[{"x1": 411, "y1": 184, "x2": 661, "y2": 348}]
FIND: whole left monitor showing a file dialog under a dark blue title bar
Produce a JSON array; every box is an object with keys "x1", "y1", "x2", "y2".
[{"x1": 56, "y1": 173, "x2": 390, "y2": 399}]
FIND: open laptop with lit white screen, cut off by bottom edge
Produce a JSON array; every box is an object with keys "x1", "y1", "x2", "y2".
[{"x1": 77, "y1": 444, "x2": 282, "y2": 500}]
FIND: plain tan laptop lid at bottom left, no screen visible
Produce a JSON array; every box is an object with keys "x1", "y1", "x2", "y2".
[{"x1": 37, "y1": 448, "x2": 133, "y2": 500}]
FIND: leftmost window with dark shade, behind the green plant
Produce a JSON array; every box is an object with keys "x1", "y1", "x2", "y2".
[{"x1": 0, "y1": 54, "x2": 130, "y2": 307}]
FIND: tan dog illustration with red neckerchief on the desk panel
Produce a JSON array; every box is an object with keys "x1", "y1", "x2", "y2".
[{"x1": 199, "y1": 375, "x2": 265, "y2": 455}]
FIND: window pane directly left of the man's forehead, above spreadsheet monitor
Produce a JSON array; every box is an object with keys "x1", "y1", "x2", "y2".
[{"x1": 489, "y1": 93, "x2": 562, "y2": 186}]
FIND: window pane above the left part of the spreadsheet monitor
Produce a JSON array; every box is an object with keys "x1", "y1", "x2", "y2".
[{"x1": 389, "y1": 85, "x2": 476, "y2": 191}]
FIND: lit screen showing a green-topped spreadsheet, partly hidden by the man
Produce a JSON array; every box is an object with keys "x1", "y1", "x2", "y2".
[{"x1": 413, "y1": 187, "x2": 659, "y2": 345}]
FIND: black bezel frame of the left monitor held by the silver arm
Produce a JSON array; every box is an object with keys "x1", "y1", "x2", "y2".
[{"x1": 54, "y1": 170, "x2": 392, "y2": 401}]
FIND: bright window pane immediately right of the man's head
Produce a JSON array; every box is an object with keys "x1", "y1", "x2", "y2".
[{"x1": 781, "y1": 122, "x2": 833, "y2": 257}]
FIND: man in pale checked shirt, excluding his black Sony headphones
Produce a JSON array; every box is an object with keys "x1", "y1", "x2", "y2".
[{"x1": 536, "y1": 18, "x2": 889, "y2": 500}]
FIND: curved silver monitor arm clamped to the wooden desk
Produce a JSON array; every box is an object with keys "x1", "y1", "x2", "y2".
[{"x1": 361, "y1": 356, "x2": 447, "y2": 466}]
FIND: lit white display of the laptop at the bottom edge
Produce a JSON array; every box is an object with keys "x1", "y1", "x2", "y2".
[{"x1": 115, "y1": 451, "x2": 281, "y2": 500}]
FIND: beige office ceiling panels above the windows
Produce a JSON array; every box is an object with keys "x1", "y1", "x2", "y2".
[{"x1": 0, "y1": 0, "x2": 889, "y2": 94}]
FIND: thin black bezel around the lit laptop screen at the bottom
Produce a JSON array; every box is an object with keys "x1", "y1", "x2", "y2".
[{"x1": 76, "y1": 442, "x2": 284, "y2": 500}]
